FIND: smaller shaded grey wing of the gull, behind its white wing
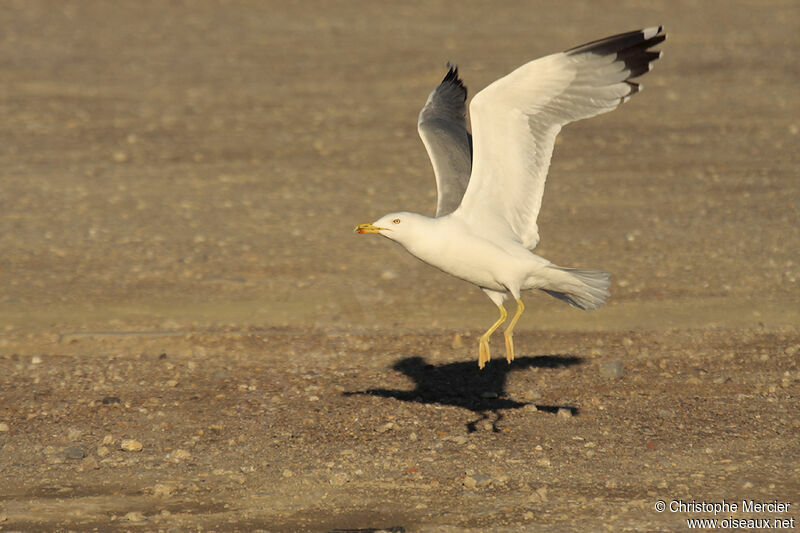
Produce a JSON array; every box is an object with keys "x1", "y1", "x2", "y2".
[{"x1": 417, "y1": 63, "x2": 472, "y2": 217}]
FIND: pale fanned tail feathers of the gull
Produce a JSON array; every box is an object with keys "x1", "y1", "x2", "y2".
[{"x1": 541, "y1": 265, "x2": 611, "y2": 311}]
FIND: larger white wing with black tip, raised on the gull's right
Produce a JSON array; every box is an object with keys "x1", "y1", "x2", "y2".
[{"x1": 456, "y1": 26, "x2": 666, "y2": 248}]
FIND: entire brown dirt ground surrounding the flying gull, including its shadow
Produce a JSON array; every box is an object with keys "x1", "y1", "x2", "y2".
[{"x1": 0, "y1": 0, "x2": 800, "y2": 533}]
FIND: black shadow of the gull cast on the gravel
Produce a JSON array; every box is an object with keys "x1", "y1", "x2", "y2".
[{"x1": 343, "y1": 355, "x2": 583, "y2": 433}]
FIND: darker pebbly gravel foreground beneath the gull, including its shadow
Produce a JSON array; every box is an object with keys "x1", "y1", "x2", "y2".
[{"x1": 0, "y1": 329, "x2": 800, "y2": 532}]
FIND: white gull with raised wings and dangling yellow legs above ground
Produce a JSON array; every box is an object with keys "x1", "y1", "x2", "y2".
[{"x1": 355, "y1": 26, "x2": 666, "y2": 369}]
